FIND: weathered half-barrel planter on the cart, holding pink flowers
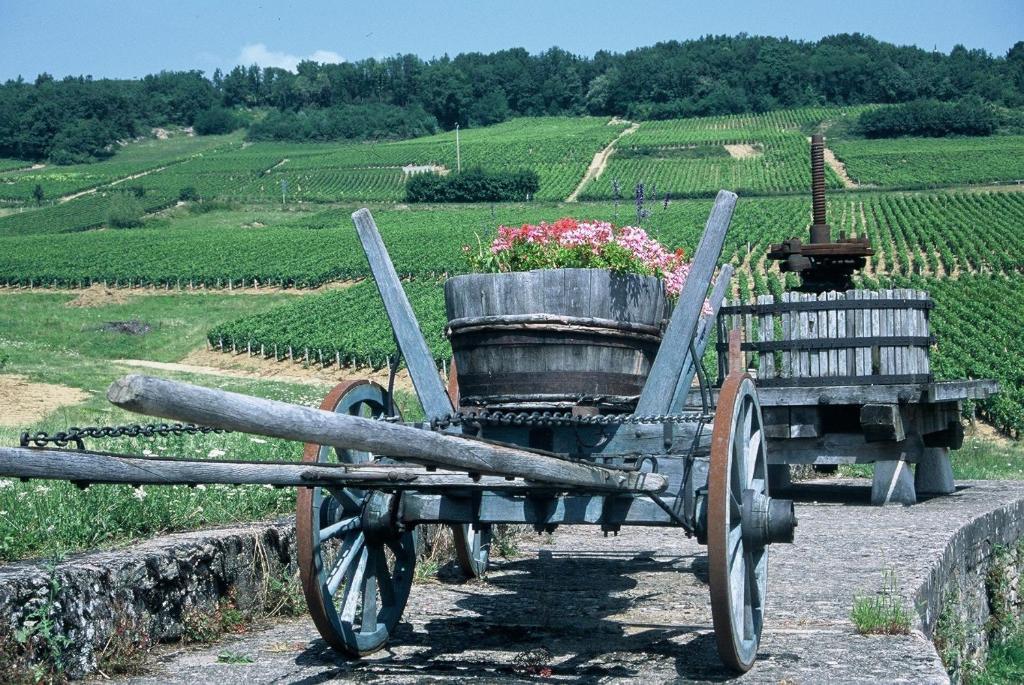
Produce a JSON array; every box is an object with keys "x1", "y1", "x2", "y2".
[{"x1": 444, "y1": 268, "x2": 669, "y2": 408}]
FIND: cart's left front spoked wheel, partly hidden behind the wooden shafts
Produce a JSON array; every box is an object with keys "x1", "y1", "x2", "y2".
[{"x1": 295, "y1": 381, "x2": 416, "y2": 656}]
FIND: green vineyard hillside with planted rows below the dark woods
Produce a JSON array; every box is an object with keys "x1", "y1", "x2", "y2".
[{"x1": 0, "y1": 106, "x2": 1024, "y2": 440}]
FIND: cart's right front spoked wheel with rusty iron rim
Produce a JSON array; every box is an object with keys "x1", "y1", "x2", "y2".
[{"x1": 708, "y1": 373, "x2": 768, "y2": 672}]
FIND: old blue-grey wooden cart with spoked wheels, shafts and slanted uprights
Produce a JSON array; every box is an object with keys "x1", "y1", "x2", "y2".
[{"x1": 0, "y1": 191, "x2": 796, "y2": 671}]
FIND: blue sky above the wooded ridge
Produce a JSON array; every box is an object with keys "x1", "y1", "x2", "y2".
[{"x1": 0, "y1": 0, "x2": 1024, "y2": 80}]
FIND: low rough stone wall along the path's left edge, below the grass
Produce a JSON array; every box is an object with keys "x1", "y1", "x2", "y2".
[{"x1": 0, "y1": 519, "x2": 297, "y2": 678}]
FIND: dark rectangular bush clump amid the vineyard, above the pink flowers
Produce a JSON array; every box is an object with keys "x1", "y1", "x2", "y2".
[{"x1": 406, "y1": 168, "x2": 541, "y2": 203}]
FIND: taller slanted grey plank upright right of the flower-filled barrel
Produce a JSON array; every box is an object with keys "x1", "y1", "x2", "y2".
[{"x1": 636, "y1": 190, "x2": 736, "y2": 415}]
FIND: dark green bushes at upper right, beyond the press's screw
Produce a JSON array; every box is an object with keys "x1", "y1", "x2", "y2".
[{"x1": 854, "y1": 96, "x2": 999, "y2": 138}]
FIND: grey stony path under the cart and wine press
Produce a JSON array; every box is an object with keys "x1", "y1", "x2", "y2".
[{"x1": 125, "y1": 482, "x2": 1024, "y2": 685}]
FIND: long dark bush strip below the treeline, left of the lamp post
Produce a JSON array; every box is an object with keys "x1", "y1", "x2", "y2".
[{"x1": 249, "y1": 103, "x2": 437, "y2": 142}]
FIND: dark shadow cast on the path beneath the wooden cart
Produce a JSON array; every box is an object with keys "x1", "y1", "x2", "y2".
[{"x1": 288, "y1": 548, "x2": 734, "y2": 683}]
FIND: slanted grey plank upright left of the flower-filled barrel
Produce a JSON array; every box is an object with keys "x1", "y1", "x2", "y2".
[{"x1": 352, "y1": 209, "x2": 454, "y2": 419}]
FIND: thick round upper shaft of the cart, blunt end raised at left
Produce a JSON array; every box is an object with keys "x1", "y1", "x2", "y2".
[{"x1": 106, "y1": 375, "x2": 668, "y2": 491}]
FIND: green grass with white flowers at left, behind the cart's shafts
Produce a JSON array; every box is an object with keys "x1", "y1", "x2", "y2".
[{"x1": 0, "y1": 292, "x2": 423, "y2": 561}]
